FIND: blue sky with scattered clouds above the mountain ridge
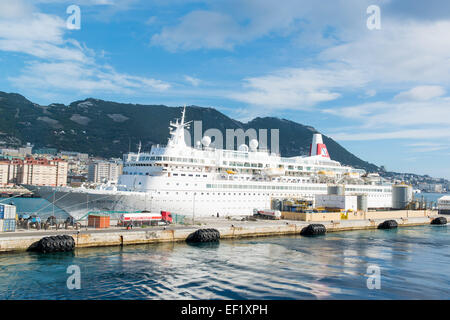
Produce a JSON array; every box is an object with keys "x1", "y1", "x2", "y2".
[{"x1": 0, "y1": 0, "x2": 450, "y2": 178}]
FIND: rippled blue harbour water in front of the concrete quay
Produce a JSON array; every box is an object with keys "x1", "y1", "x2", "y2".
[{"x1": 0, "y1": 226, "x2": 450, "y2": 299}]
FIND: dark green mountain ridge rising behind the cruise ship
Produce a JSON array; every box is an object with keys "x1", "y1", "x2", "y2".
[{"x1": 0, "y1": 92, "x2": 379, "y2": 172}]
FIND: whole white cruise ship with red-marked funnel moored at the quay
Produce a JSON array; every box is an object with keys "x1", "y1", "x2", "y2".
[{"x1": 26, "y1": 109, "x2": 392, "y2": 219}]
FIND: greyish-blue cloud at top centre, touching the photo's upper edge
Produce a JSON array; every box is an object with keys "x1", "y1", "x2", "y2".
[{"x1": 151, "y1": 0, "x2": 373, "y2": 51}]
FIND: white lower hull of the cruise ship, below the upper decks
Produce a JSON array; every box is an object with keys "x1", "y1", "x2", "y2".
[{"x1": 26, "y1": 184, "x2": 392, "y2": 219}]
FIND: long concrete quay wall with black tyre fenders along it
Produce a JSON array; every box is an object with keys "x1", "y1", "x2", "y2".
[{"x1": 0, "y1": 211, "x2": 444, "y2": 252}]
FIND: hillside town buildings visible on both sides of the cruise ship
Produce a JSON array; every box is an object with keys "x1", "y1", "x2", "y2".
[{"x1": 0, "y1": 143, "x2": 450, "y2": 197}]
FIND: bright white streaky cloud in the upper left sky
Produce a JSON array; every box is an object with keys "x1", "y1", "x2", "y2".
[{"x1": 0, "y1": 0, "x2": 170, "y2": 99}]
